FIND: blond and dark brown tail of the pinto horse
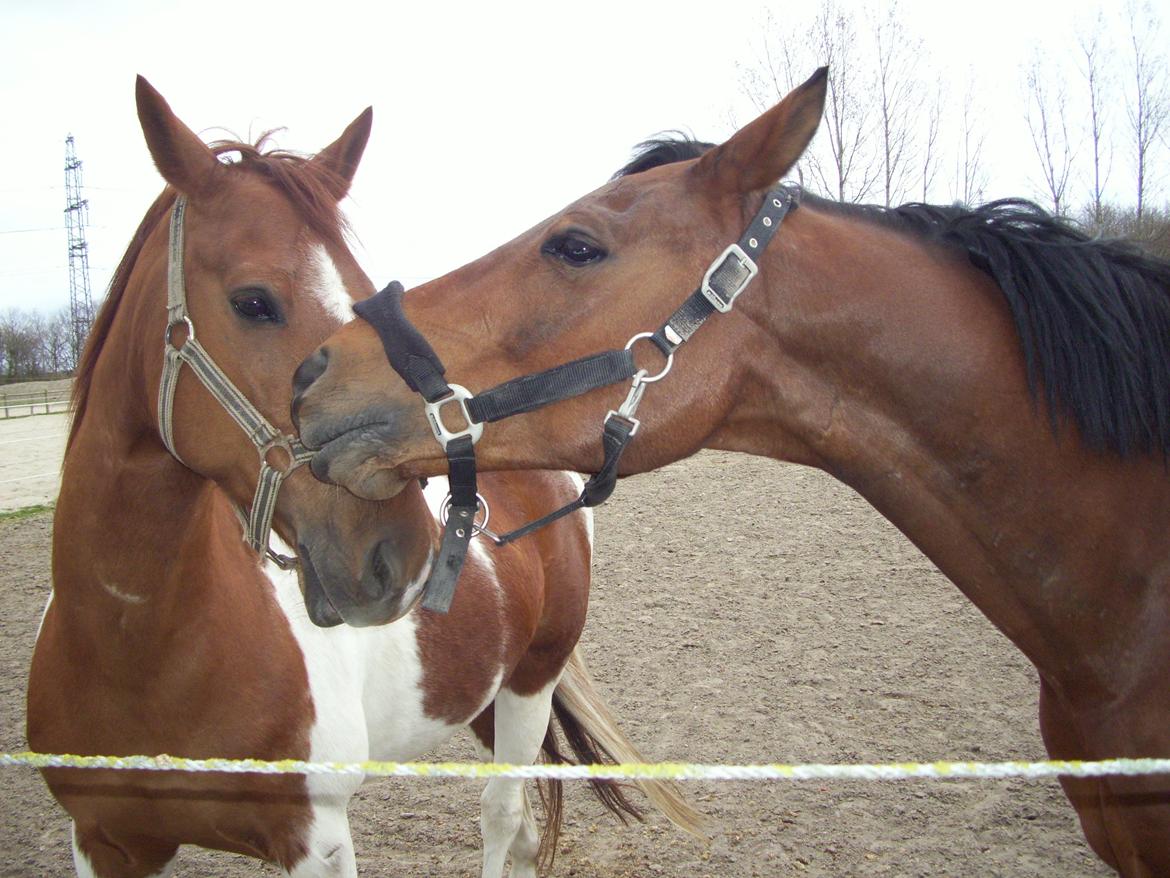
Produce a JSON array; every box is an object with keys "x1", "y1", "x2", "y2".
[{"x1": 539, "y1": 646, "x2": 709, "y2": 866}]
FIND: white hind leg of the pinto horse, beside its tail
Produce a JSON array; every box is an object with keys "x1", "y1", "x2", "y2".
[{"x1": 480, "y1": 680, "x2": 556, "y2": 878}]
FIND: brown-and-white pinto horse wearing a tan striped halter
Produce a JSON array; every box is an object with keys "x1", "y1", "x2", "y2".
[{"x1": 28, "y1": 77, "x2": 697, "y2": 878}]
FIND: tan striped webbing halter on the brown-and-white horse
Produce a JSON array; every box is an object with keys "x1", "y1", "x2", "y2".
[{"x1": 158, "y1": 194, "x2": 314, "y2": 570}]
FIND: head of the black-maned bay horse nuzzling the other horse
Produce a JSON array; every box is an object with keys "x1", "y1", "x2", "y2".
[{"x1": 295, "y1": 70, "x2": 826, "y2": 498}]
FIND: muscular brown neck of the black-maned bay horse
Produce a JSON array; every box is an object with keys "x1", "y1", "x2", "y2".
[{"x1": 725, "y1": 207, "x2": 1170, "y2": 679}]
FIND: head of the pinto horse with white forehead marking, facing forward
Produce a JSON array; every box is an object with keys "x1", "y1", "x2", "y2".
[{"x1": 90, "y1": 77, "x2": 436, "y2": 625}]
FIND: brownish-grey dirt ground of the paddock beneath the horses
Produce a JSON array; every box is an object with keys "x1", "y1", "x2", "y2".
[{"x1": 0, "y1": 453, "x2": 1112, "y2": 878}]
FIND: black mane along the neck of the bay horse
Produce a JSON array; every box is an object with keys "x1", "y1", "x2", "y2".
[{"x1": 806, "y1": 197, "x2": 1170, "y2": 459}]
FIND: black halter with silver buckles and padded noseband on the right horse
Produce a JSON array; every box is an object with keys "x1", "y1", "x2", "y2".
[{"x1": 353, "y1": 185, "x2": 799, "y2": 612}]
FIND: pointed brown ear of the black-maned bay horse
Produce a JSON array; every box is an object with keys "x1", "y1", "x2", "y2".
[{"x1": 691, "y1": 67, "x2": 828, "y2": 194}]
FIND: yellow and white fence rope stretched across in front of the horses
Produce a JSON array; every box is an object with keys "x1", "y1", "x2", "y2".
[{"x1": 0, "y1": 752, "x2": 1170, "y2": 781}]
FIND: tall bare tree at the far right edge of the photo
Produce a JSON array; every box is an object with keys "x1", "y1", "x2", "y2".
[{"x1": 1126, "y1": 2, "x2": 1170, "y2": 222}]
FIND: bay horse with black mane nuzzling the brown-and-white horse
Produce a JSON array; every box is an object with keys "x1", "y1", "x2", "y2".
[{"x1": 294, "y1": 70, "x2": 1170, "y2": 877}]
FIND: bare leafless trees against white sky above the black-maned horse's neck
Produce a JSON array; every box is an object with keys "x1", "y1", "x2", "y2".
[{"x1": 741, "y1": 0, "x2": 1170, "y2": 258}]
